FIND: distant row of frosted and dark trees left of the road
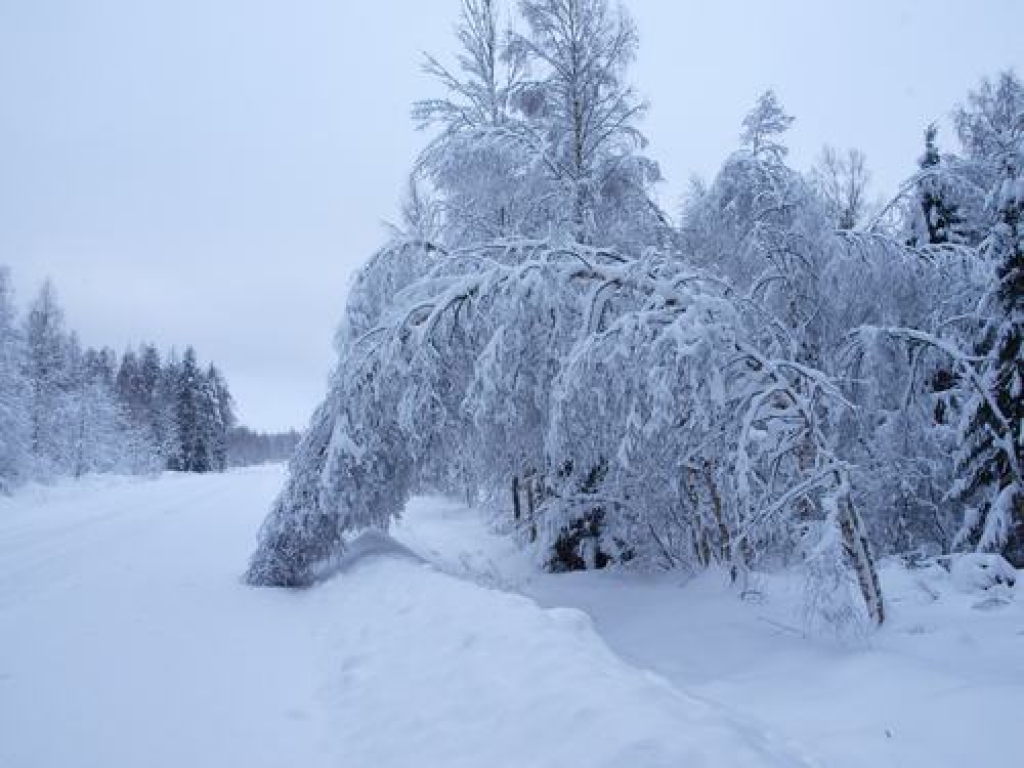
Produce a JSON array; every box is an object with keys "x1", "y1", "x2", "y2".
[{"x1": 0, "y1": 266, "x2": 295, "y2": 490}]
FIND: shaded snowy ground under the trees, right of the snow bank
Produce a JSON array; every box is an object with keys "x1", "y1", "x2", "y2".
[{"x1": 395, "y1": 500, "x2": 1024, "y2": 768}]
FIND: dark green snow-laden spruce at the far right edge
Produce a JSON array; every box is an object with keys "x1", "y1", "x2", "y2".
[{"x1": 954, "y1": 157, "x2": 1024, "y2": 567}]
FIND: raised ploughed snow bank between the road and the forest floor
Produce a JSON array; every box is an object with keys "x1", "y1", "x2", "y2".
[{"x1": 315, "y1": 558, "x2": 806, "y2": 768}]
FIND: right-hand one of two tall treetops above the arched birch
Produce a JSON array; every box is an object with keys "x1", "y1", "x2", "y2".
[{"x1": 509, "y1": 0, "x2": 664, "y2": 247}]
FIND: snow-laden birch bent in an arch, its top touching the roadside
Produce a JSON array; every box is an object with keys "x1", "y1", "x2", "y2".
[{"x1": 248, "y1": 240, "x2": 884, "y2": 622}]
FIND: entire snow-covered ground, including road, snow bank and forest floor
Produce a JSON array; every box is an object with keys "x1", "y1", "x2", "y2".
[{"x1": 0, "y1": 468, "x2": 1024, "y2": 768}]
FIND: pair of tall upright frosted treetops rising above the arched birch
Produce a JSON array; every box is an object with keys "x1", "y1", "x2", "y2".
[{"x1": 411, "y1": 0, "x2": 668, "y2": 248}]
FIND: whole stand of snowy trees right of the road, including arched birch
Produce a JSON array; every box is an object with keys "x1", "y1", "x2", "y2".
[{"x1": 247, "y1": 18, "x2": 1022, "y2": 638}]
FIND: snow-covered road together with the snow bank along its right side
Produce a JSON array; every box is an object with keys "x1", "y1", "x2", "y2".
[{"x1": 0, "y1": 468, "x2": 803, "y2": 768}]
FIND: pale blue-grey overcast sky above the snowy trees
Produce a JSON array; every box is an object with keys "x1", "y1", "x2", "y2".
[{"x1": 0, "y1": 0, "x2": 1024, "y2": 429}]
